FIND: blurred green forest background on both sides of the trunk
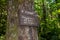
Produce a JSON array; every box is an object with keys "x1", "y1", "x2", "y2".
[{"x1": 0, "y1": 0, "x2": 60, "y2": 40}]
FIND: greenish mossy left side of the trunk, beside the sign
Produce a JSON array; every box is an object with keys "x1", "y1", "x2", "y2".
[{"x1": 6, "y1": 0, "x2": 18, "y2": 40}]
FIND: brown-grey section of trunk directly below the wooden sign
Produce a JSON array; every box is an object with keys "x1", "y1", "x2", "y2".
[{"x1": 18, "y1": 26, "x2": 38, "y2": 40}]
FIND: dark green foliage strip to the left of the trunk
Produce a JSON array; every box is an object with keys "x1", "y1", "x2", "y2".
[{"x1": 0, "y1": 0, "x2": 7, "y2": 40}]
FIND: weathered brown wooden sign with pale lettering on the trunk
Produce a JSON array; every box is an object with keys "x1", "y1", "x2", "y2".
[{"x1": 19, "y1": 10, "x2": 38, "y2": 26}]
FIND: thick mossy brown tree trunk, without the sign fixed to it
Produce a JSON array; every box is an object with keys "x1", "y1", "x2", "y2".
[{"x1": 6, "y1": 0, "x2": 38, "y2": 40}]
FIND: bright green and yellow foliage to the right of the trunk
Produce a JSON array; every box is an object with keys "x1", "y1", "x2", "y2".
[{"x1": 34, "y1": 0, "x2": 60, "y2": 40}]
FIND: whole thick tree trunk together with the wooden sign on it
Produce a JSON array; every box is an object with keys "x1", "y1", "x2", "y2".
[{"x1": 6, "y1": 0, "x2": 38, "y2": 40}]
